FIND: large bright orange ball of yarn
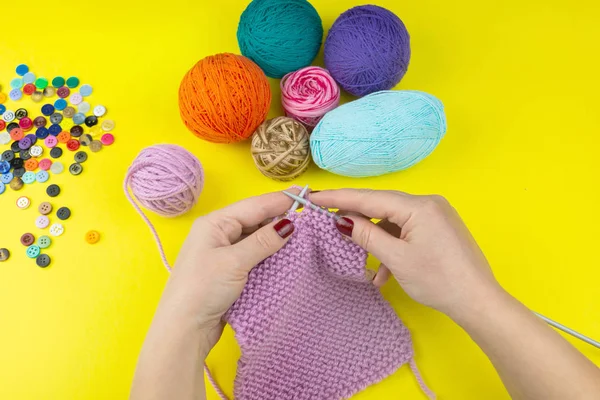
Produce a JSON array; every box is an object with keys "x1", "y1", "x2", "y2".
[{"x1": 179, "y1": 53, "x2": 271, "y2": 143}]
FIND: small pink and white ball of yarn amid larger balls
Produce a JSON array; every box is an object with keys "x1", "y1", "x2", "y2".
[{"x1": 281, "y1": 67, "x2": 340, "y2": 127}]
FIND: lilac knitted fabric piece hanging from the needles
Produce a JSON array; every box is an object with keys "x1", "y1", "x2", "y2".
[{"x1": 224, "y1": 208, "x2": 433, "y2": 400}]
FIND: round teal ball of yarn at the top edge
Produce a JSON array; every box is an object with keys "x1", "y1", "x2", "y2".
[{"x1": 237, "y1": 0, "x2": 323, "y2": 78}]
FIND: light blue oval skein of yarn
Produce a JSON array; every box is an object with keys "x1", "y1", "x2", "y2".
[{"x1": 310, "y1": 90, "x2": 446, "y2": 177}]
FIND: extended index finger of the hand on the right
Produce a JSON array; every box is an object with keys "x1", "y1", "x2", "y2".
[{"x1": 309, "y1": 189, "x2": 418, "y2": 227}]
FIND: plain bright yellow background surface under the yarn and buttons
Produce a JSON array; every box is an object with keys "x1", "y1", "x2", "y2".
[{"x1": 0, "y1": 0, "x2": 600, "y2": 400}]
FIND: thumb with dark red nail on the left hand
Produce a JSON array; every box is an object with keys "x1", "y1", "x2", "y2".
[{"x1": 231, "y1": 218, "x2": 294, "y2": 272}]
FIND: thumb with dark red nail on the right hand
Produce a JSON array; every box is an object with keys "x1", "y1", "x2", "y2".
[{"x1": 336, "y1": 216, "x2": 406, "y2": 264}]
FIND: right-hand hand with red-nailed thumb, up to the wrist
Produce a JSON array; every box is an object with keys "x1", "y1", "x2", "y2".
[{"x1": 310, "y1": 189, "x2": 502, "y2": 319}]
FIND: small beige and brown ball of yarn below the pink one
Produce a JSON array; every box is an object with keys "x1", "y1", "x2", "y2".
[{"x1": 252, "y1": 117, "x2": 310, "y2": 181}]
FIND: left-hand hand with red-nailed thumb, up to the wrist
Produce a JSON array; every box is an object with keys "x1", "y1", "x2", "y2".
[{"x1": 159, "y1": 192, "x2": 294, "y2": 352}]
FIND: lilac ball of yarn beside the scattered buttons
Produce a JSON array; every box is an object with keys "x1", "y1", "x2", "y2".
[{"x1": 125, "y1": 144, "x2": 204, "y2": 217}]
